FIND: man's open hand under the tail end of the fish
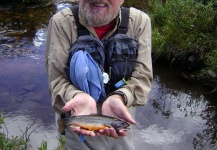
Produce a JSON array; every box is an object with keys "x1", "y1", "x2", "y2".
[{"x1": 62, "y1": 92, "x2": 97, "y2": 136}]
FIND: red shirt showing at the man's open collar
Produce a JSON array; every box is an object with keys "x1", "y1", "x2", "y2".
[{"x1": 94, "y1": 21, "x2": 115, "y2": 39}]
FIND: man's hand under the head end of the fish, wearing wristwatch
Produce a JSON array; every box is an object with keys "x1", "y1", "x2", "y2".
[{"x1": 97, "y1": 95, "x2": 136, "y2": 138}]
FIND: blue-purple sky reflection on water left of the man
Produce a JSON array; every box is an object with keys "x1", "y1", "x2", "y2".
[{"x1": 0, "y1": 25, "x2": 58, "y2": 150}]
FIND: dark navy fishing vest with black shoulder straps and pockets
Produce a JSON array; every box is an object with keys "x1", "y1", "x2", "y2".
[{"x1": 70, "y1": 5, "x2": 138, "y2": 94}]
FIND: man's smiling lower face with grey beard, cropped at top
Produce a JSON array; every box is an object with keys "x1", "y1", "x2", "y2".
[{"x1": 79, "y1": 0, "x2": 124, "y2": 27}]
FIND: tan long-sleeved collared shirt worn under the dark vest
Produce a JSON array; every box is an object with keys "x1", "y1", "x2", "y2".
[{"x1": 45, "y1": 8, "x2": 153, "y2": 113}]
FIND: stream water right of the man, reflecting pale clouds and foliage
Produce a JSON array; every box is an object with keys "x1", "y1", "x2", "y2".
[{"x1": 133, "y1": 66, "x2": 217, "y2": 150}]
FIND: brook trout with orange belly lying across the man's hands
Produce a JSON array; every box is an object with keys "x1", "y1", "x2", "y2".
[{"x1": 57, "y1": 114, "x2": 130, "y2": 134}]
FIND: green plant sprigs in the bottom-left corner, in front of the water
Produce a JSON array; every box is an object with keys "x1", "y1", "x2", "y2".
[{"x1": 0, "y1": 112, "x2": 65, "y2": 150}]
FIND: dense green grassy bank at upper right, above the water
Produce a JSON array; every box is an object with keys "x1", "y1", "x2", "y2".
[{"x1": 146, "y1": 0, "x2": 217, "y2": 87}]
